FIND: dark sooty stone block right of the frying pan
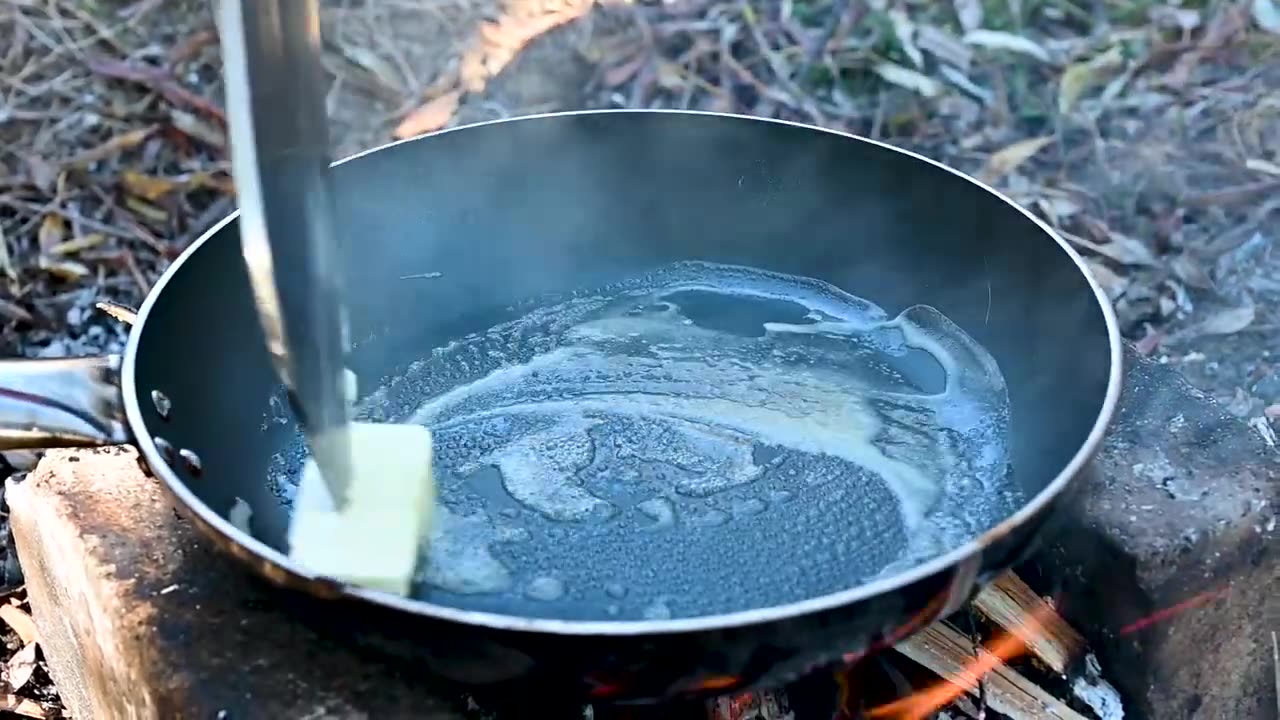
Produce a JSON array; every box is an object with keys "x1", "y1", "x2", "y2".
[{"x1": 1023, "y1": 352, "x2": 1280, "y2": 720}]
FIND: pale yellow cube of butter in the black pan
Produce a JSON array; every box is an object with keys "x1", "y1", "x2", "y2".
[{"x1": 289, "y1": 423, "x2": 435, "y2": 596}]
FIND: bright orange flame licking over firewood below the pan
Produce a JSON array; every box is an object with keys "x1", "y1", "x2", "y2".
[{"x1": 867, "y1": 605, "x2": 1053, "y2": 720}]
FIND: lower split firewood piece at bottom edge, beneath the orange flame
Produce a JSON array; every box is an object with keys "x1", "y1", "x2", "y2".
[{"x1": 897, "y1": 623, "x2": 1087, "y2": 720}]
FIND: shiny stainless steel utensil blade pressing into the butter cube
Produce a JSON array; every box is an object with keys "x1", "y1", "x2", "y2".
[{"x1": 219, "y1": 0, "x2": 351, "y2": 506}]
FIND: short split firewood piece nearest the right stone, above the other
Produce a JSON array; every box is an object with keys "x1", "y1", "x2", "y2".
[{"x1": 973, "y1": 573, "x2": 1084, "y2": 675}]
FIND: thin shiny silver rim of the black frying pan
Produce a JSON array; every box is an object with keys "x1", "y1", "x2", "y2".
[{"x1": 120, "y1": 109, "x2": 1124, "y2": 637}]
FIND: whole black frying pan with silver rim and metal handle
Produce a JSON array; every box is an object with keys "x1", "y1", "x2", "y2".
[{"x1": 0, "y1": 111, "x2": 1120, "y2": 701}]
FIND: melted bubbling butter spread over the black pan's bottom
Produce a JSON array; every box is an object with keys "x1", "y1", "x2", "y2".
[{"x1": 270, "y1": 261, "x2": 1027, "y2": 620}]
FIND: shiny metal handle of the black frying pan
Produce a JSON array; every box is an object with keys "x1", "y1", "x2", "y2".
[{"x1": 0, "y1": 355, "x2": 133, "y2": 451}]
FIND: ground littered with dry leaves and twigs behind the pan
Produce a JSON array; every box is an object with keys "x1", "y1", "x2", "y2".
[{"x1": 0, "y1": 0, "x2": 1280, "y2": 717}]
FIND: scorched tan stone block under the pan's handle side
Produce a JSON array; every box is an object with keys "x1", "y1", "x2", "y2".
[{"x1": 5, "y1": 447, "x2": 465, "y2": 720}]
